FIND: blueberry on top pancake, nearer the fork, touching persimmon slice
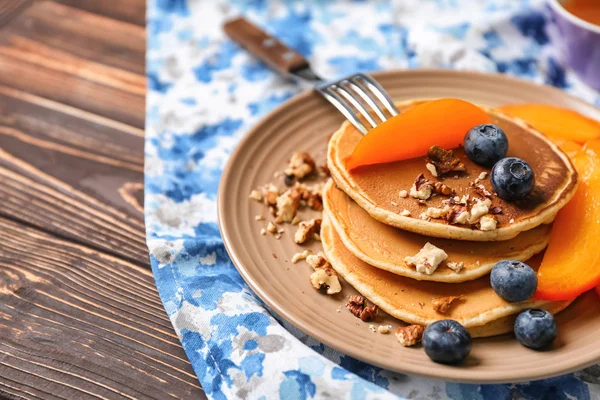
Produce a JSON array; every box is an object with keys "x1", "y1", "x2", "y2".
[{"x1": 464, "y1": 124, "x2": 508, "y2": 168}]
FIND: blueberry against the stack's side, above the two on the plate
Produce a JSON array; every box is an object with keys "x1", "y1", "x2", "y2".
[{"x1": 490, "y1": 260, "x2": 537, "y2": 303}]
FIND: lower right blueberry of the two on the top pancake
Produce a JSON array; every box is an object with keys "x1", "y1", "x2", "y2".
[{"x1": 490, "y1": 157, "x2": 535, "y2": 201}]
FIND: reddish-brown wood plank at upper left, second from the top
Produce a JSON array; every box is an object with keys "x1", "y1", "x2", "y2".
[{"x1": 0, "y1": 1, "x2": 146, "y2": 128}]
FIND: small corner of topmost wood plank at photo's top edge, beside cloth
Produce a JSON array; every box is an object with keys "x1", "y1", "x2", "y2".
[{"x1": 53, "y1": 0, "x2": 146, "y2": 26}]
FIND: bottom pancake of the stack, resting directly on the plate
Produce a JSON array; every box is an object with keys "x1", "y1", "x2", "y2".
[{"x1": 321, "y1": 214, "x2": 571, "y2": 336}]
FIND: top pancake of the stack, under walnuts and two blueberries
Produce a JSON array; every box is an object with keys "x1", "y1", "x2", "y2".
[{"x1": 327, "y1": 101, "x2": 577, "y2": 241}]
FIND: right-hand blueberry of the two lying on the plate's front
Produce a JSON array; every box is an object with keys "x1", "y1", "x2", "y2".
[{"x1": 515, "y1": 308, "x2": 558, "y2": 349}]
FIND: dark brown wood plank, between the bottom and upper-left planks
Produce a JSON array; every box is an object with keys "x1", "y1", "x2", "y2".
[{"x1": 0, "y1": 86, "x2": 148, "y2": 265}]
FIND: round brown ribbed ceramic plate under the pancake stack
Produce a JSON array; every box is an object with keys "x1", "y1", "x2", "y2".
[{"x1": 218, "y1": 70, "x2": 600, "y2": 383}]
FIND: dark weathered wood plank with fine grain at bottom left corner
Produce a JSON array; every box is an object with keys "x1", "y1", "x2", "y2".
[{"x1": 0, "y1": 218, "x2": 204, "y2": 399}]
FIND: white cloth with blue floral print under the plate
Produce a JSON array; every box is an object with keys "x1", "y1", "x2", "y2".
[{"x1": 145, "y1": 0, "x2": 600, "y2": 400}]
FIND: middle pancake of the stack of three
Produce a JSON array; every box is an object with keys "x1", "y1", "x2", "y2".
[{"x1": 323, "y1": 180, "x2": 551, "y2": 283}]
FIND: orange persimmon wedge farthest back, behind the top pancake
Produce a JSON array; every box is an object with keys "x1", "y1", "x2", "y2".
[{"x1": 499, "y1": 104, "x2": 600, "y2": 144}]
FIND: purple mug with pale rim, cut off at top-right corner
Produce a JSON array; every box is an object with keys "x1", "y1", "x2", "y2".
[{"x1": 548, "y1": 0, "x2": 600, "y2": 90}]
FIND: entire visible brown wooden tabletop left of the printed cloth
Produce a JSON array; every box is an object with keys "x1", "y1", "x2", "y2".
[{"x1": 0, "y1": 0, "x2": 205, "y2": 399}]
